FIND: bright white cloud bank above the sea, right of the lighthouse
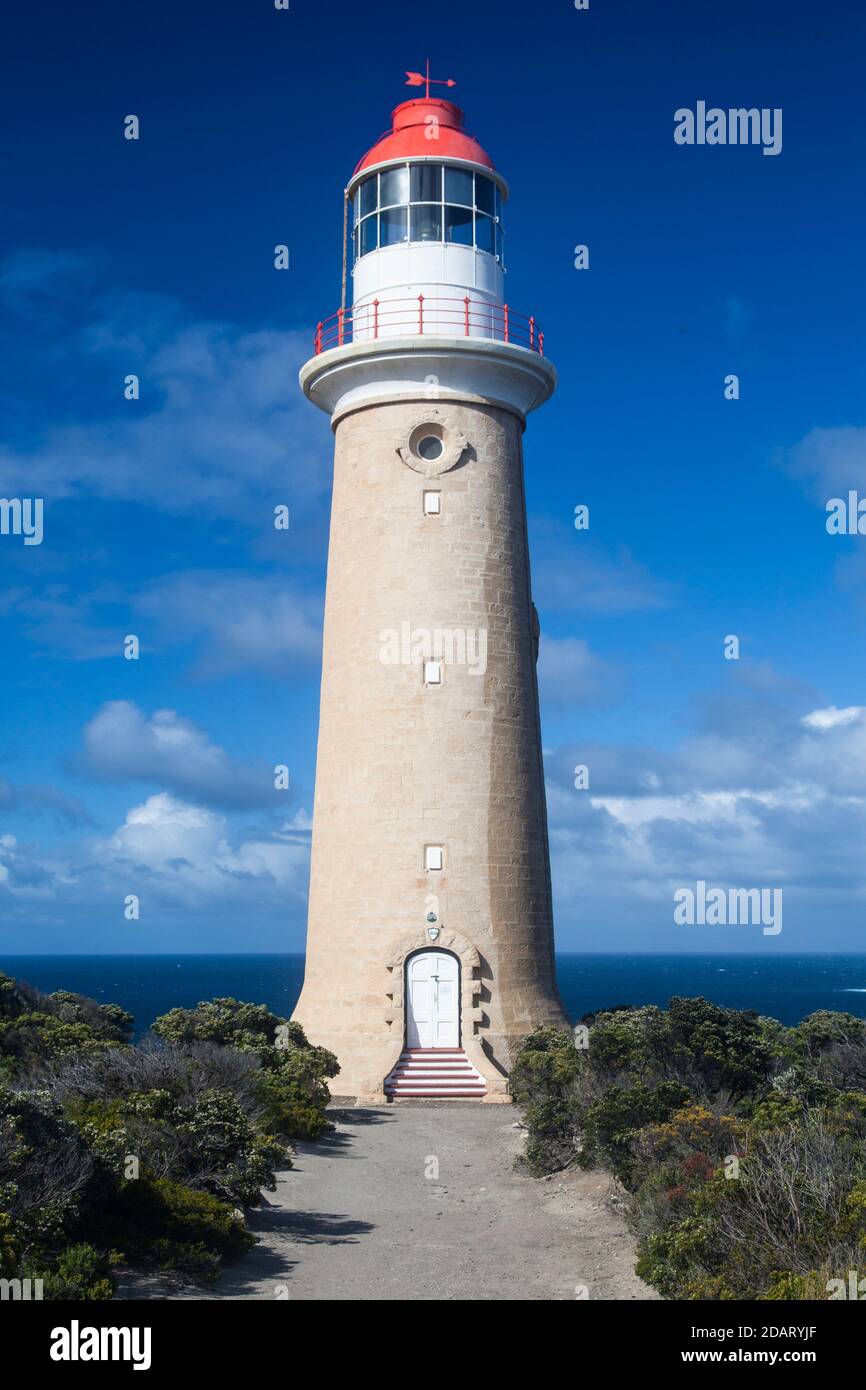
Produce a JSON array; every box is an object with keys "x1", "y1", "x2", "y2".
[{"x1": 546, "y1": 689, "x2": 866, "y2": 951}]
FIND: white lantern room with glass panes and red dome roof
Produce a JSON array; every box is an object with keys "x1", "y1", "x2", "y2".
[{"x1": 346, "y1": 96, "x2": 507, "y2": 342}]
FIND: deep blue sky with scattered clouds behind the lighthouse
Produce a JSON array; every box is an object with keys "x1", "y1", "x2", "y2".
[{"x1": 0, "y1": 0, "x2": 866, "y2": 952}]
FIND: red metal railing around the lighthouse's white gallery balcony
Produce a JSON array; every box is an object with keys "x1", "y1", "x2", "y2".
[{"x1": 313, "y1": 295, "x2": 545, "y2": 357}]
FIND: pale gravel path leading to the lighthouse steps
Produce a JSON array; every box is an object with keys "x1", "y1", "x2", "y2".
[{"x1": 204, "y1": 1101, "x2": 656, "y2": 1301}]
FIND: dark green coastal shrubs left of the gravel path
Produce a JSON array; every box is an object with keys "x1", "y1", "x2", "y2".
[{"x1": 0, "y1": 974, "x2": 338, "y2": 1300}]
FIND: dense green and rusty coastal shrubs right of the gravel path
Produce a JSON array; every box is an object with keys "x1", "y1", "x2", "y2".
[{"x1": 514, "y1": 999, "x2": 866, "y2": 1301}]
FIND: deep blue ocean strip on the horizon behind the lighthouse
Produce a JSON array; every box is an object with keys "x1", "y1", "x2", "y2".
[{"x1": 0, "y1": 954, "x2": 866, "y2": 1037}]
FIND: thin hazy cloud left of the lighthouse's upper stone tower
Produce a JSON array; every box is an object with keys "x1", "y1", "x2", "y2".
[{"x1": 0, "y1": 284, "x2": 331, "y2": 525}]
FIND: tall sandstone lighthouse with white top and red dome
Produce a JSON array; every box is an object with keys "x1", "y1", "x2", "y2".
[{"x1": 295, "y1": 74, "x2": 567, "y2": 1102}]
